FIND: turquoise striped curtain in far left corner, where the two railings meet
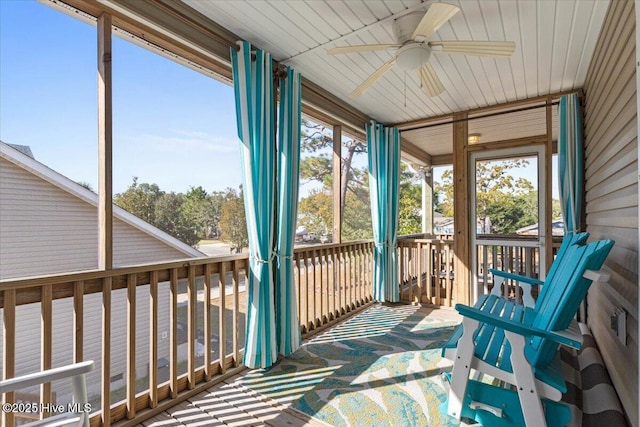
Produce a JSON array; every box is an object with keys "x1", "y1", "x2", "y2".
[{"x1": 367, "y1": 121, "x2": 400, "y2": 302}]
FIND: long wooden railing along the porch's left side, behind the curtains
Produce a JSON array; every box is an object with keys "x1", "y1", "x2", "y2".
[{"x1": 0, "y1": 242, "x2": 373, "y2": 427}]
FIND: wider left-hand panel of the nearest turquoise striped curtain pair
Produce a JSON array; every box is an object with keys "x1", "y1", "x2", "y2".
[{"x1": 231, "y1": 42, "x2": 277, "y2": 368}]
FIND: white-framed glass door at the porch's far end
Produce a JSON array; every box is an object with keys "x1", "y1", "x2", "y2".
[{"x1": 469, "y1": 145, "x2": 547, "y2": 302}]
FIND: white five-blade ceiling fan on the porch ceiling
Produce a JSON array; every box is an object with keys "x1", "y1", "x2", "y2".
[{"x1": 327, "y1": 3, "x2": 516, "y2": 98}]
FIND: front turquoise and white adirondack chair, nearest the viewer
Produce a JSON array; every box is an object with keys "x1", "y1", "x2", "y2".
[{"x1": 443, "y1": 240, "x2": 614, "y2": 427}]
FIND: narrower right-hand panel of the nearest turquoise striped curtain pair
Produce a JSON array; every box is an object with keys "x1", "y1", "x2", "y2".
[{"x1": 275, "y1": 67, "x2": 302, "y2": 356}]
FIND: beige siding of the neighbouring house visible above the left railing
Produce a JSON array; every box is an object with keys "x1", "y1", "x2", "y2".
[{"x1": 0, "y1": 158, "x2": 192, "y2": 279}]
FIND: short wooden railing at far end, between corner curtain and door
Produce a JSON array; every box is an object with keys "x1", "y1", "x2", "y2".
[{"x1": 398, "y1": 236, "x2": 455, "y2": 307}]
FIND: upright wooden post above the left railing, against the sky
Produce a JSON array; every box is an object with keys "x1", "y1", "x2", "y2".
[{"x1": 98, "y1": 13, "x2": 113, "y2": 270}]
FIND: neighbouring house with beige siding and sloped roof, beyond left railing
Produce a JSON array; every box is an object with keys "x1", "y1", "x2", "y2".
[{"x1": 0, "y1": 141, "x2": 205, "y2": 401}]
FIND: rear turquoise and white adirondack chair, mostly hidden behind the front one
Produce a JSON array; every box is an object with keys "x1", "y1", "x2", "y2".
[{"x1": 489, "y1": 232, "x2": 589, "y2": 307}]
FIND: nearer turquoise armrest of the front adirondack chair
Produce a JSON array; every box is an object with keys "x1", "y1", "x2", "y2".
[{"x1": 455, "y1": 304, "x2": 582, "y2": 349}]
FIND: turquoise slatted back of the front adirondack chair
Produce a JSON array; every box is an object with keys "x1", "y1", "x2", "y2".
[{"x1": 526, "y1": 240, "x2": 614, "y2": 366}]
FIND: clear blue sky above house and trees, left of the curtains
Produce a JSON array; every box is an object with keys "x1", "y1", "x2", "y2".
[{"x1": 0, "y1": 0, "x2": 241, "y2": 193}]
